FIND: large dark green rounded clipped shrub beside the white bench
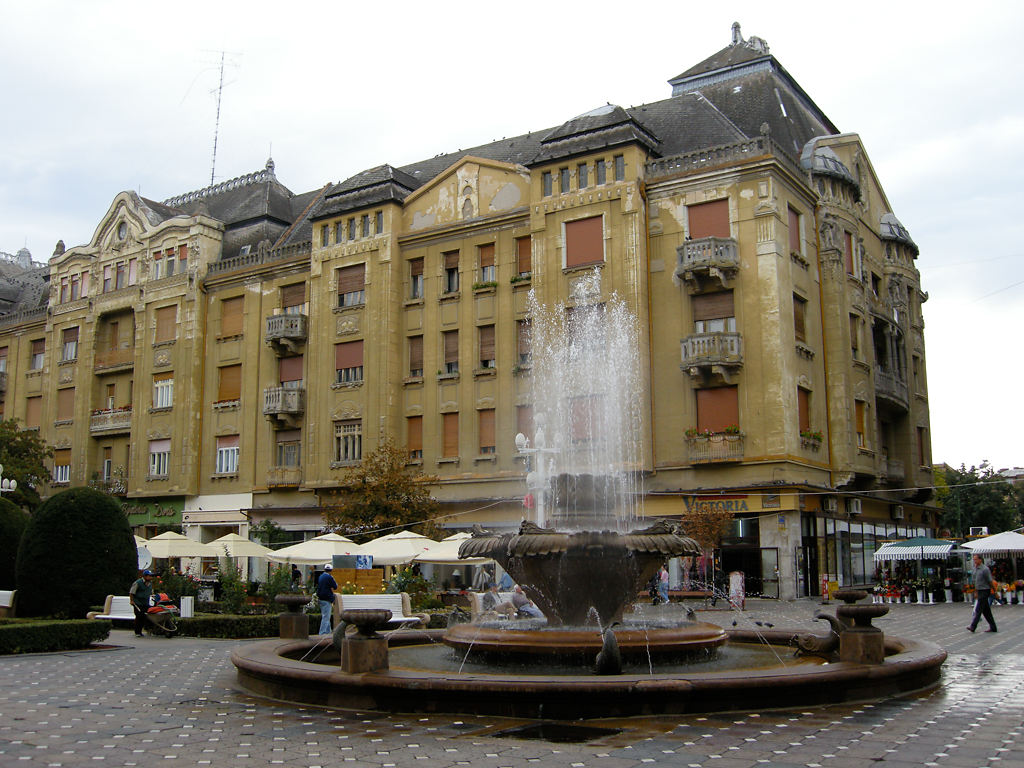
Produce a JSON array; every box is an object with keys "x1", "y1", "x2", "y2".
[{"x1": 16, "y1": 487, "x2": 138, "y2": 618}]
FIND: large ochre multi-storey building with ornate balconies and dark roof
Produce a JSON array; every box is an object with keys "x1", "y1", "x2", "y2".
[{"x1": 0, "y1": 26, "x2": 935, "y2": 598}]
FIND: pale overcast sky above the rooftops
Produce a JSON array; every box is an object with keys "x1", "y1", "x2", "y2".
[{"x1": 0, "y1": 0, "x2": 1024, "y2": 467}]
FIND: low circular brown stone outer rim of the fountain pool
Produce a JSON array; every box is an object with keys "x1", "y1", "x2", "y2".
[{"x1": 231, "y1": 630, "x2": 946, "y2": 719}]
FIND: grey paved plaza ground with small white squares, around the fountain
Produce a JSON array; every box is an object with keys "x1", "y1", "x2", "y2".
[{"x1": 0, "y1": 600, "x2": 1024, "y2": 768}]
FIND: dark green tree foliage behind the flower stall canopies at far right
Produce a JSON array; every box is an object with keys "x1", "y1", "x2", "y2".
[{"x1": 936, "y1": 461, "x2": 1024, "y2": 537}]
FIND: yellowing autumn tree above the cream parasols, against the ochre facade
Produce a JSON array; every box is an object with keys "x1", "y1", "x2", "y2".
[{"x1": 324, "y1": 440, "x2": 438, "y2": 542}]
